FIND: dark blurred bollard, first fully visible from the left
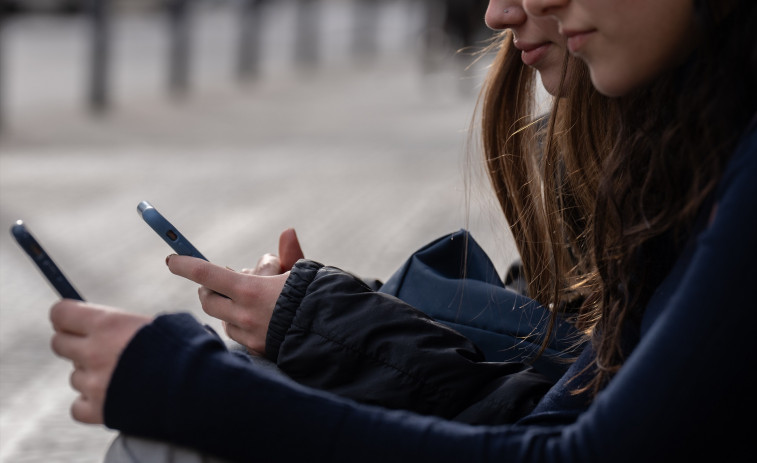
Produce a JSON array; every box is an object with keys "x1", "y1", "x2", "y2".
[{"x1": 88, "y1": 0, "x2": 112, "y2": 114}]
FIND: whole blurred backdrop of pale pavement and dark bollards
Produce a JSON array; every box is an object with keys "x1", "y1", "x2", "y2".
[{"x1": 0, "y1": 0, "x2": 516, "y2": 462}]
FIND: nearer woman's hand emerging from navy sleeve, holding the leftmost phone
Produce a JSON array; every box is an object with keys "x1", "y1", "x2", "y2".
[{"x1": 50, "y1": 299, "x2": 152, "y2": 424}]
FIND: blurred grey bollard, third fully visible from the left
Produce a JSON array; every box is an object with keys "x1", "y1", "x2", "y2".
[{"x1": 237, "y1": 0, "x2": 266, "y2": 81}]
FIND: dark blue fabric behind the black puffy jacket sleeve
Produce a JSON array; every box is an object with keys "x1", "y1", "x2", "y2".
[{"x1": 379, "y1": 230, "x2": 576, "y2": 380}]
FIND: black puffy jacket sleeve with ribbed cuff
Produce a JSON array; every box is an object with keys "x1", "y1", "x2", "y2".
[{"x1": 266, "y1": 260, "x2": 552, "y2": 424}]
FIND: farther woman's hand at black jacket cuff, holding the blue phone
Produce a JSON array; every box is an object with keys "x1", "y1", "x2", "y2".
[{"x1": 166, "y1": 254, "x2": 289, "y2": 355}]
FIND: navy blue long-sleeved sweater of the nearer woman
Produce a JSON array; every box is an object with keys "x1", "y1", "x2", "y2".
[{"x1": 105, "y1": 125, "x2": 757, "y2": 462}]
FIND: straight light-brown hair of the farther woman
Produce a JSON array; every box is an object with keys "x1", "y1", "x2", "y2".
[{"x1": 479, "y1": 32, "x2": 617, "y2": 348}]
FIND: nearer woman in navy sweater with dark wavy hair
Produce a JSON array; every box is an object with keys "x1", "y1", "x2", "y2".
[{"x1": 51, "y1": 0, "x2": 757, "y2": 461}]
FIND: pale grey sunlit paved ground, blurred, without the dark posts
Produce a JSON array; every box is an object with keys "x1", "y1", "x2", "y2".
[{"x1": 0, "y1": 1, "x2": 513, "y2": 462}]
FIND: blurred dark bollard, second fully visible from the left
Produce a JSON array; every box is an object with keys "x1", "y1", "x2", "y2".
[{"x1": 166, "y1": 0, "x2": 192, "y2": 98}]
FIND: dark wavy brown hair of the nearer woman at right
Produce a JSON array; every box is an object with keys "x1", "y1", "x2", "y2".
[{"x1": 581, "y1": 0, "x2": 757, "y2": 392}]
